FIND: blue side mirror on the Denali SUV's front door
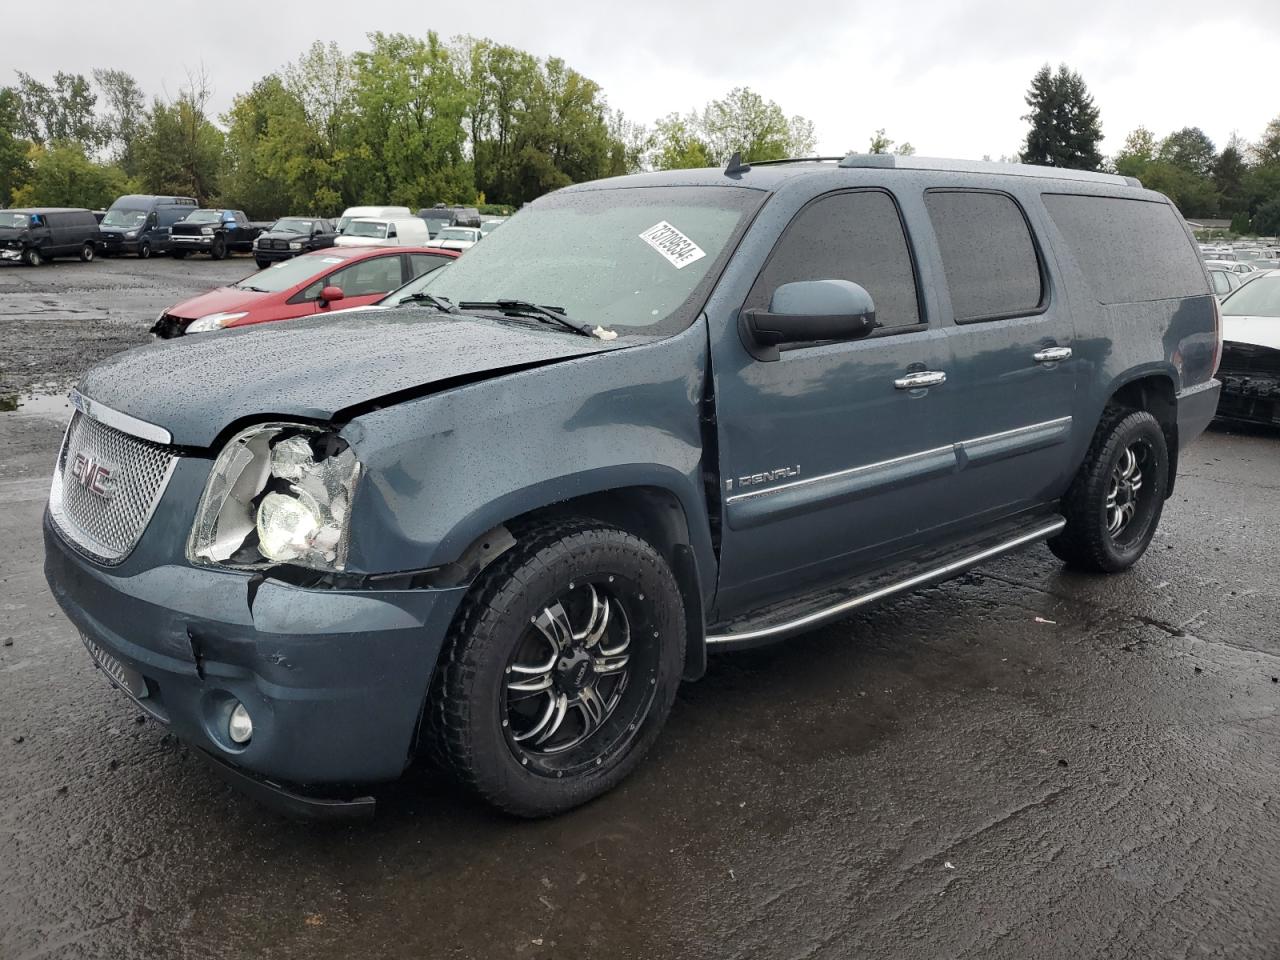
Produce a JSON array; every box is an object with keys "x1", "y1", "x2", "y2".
[{"x1": 742, "y1": 280, "x2": 879, "y2": 360}]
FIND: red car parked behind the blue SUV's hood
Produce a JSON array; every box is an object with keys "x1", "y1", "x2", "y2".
[{"x1": 151, "y1": 247, "x2": 458, "y2": 339}]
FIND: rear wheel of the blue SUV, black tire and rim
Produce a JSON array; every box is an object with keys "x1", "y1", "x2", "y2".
[{"x1": 1048, "y1": 407, "x2": 1169, "y2": 573}]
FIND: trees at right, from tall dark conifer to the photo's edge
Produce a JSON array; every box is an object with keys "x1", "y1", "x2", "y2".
[{"x1": 1020, "y1": 65, "x2": 1280, "y2": 236}]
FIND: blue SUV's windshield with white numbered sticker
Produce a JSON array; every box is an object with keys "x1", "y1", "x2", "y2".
[{"x1": 401, "y1": 187, "x2": 765, "y2": 333}]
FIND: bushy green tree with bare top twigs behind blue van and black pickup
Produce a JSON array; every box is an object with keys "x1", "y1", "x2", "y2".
[{"x1": 138, "y1": 77, "x2": 224, "y2": 204}]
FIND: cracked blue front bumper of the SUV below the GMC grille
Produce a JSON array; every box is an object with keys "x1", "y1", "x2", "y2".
[{"x1": 45, "y1": 512, "x2": 463, "y2": 803}]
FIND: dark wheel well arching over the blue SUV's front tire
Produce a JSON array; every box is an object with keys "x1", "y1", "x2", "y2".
[{"x1": 506, "y1": 486, "x2": 707, "y2": 680}]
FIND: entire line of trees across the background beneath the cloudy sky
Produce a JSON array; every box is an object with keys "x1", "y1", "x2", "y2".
[{"x1": 0, "y1": 43, "x2": 1280, "y2": 233}]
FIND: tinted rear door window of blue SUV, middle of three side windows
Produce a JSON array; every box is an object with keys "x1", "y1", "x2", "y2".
[{"x1": 924, "y1": 189, "x2": 1043, "y2": 324}]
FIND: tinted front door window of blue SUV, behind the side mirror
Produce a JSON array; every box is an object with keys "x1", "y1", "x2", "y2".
[{"x1": 746, "y1": 191, "x2": 920, "y2": 326}]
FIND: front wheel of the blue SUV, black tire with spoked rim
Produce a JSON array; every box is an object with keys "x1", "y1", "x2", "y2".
[{"x1": 424, "y1": 521, "x2": 685, "y2": 817}]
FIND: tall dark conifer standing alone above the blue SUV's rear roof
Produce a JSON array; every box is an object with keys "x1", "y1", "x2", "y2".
[{"x1": 1021, "y1": 64, "x2": 1102, "y2": 170}]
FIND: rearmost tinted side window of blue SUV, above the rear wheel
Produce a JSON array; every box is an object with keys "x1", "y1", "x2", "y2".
[{"x1": 1043, "y1": 193, "x2": 1207, "y2": 303}]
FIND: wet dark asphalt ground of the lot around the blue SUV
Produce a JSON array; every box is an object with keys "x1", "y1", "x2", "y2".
[{"x1": 0, "y1": 260, "x2": 1280, "y2": 960}]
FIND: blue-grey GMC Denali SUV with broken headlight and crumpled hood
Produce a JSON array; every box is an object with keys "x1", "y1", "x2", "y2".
[{"x1": 45, "y1": 156, "x2": 1221, "y2": 815}]
